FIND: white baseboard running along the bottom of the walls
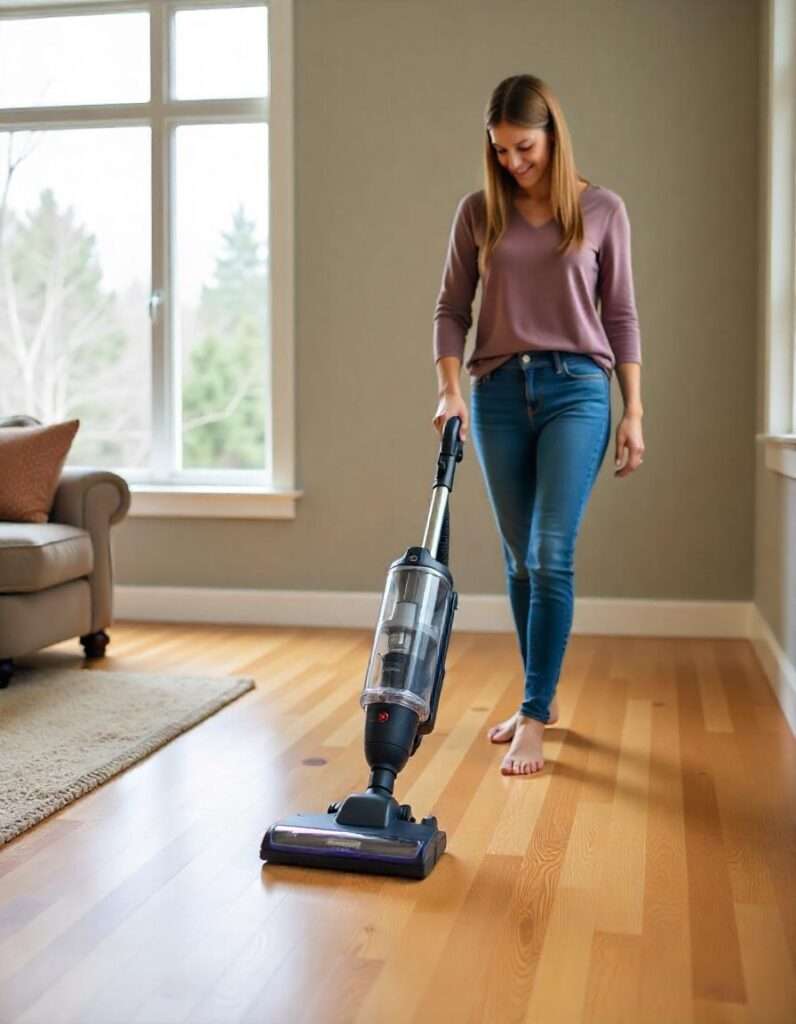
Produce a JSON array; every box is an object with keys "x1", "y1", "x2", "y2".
[{"x1": 114, "y1": 586, "x2": 796, "y2": 735}]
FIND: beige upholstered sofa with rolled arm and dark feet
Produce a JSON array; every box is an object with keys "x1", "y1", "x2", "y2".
[{"x1": 0, "y1": 416, "x2": 130, "y2": 689}]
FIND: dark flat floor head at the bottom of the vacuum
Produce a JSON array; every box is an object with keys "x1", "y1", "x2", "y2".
[{"x1": 260, "y1": 814, "x2": 446, "y2": 879}]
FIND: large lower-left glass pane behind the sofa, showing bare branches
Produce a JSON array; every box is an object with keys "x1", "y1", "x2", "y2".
[{"x1": 0, "y1": 127, "x2": 152, "y2": 469}]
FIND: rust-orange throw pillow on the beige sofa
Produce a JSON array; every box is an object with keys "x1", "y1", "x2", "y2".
[{"x1": 0, "y1": 420, "x2": 80, "y2": 522}]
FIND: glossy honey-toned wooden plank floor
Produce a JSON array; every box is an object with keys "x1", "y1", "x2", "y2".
[{"x1": 0, "y1": 623, "x2": 796, "y2": 1024}]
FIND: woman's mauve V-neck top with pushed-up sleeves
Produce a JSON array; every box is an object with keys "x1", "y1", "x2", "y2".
[{"x1": 433, "y1": 184, "x2": 641, "y2": 377}]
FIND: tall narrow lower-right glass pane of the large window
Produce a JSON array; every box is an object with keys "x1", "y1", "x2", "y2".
[{"x1": 175, "y1": 124, "x2": 270, "y2": 470}]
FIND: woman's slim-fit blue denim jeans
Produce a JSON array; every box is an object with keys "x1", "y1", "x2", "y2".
[{"x1": 470, "y1": 351, "x2": 611, "y2": 722}]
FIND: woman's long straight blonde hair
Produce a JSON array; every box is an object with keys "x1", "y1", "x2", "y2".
[{"x1": 478, "y1": 75, "x2": 591, "y2": 274}]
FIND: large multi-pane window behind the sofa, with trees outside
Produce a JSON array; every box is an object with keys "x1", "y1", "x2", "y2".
[{"x1": 0, "y1": 0, "x2": 297, "y2": 516}]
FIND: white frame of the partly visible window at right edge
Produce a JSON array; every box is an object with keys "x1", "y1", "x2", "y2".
[{"x1": 756, "y1": 0, "x2": 796, "y2": 478}]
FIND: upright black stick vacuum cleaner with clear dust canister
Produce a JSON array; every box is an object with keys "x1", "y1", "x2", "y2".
[{"x1": 260, "y1": 417, "x2": 464, "y2": 879}]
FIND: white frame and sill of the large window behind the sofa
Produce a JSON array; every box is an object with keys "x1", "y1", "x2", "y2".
[{"x1": 0, "y1": 0, "x2": 303, "y2": 518}]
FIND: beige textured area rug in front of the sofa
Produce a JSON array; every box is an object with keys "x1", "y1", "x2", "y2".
[{"x1": 0, "y1": 666, "x2": 254, "y2": 846}]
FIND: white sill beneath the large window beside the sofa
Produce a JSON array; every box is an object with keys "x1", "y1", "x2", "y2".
[{"x1": 127, "y1": 483, "x2": 304, "y2": 519}]
